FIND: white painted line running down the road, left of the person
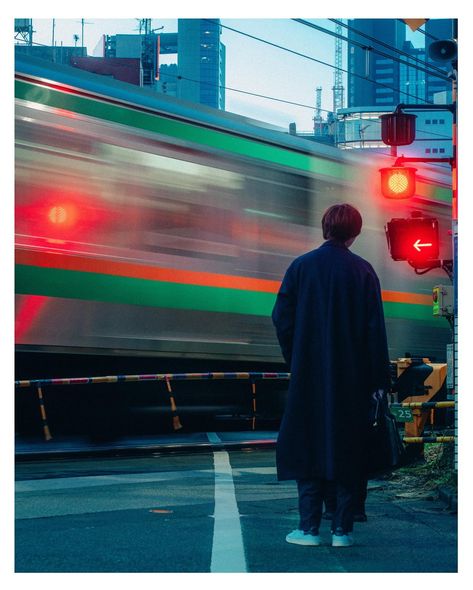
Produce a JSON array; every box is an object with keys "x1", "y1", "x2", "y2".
[{"x1": 207, "y1": 433, "x2": 248, "y2": 573}]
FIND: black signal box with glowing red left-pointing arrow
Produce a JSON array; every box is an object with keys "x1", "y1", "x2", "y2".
[{"x1": 385, "y1": 217, "x2": 439, "y2": 268}]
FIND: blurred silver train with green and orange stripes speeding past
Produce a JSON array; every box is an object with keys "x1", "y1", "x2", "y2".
[{"x1": 15, "y1": 56, "x2": 451, "y2": 378}]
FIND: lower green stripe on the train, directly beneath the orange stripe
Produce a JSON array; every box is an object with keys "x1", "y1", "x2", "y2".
[{"x1": 15, "y1": 264, "x2": 441, "y2": 327}]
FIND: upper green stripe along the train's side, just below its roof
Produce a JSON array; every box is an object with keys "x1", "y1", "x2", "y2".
[{"x1": 15, "y1": 80, "x2": 346, "y2": 179}]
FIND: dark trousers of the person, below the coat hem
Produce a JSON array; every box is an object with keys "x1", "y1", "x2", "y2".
[{"x1": 297, "y1": 478, "x2": 356, "y2": 533}]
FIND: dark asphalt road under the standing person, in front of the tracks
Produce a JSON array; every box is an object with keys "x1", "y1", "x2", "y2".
[{"x1": 15, "y1": 447, "x2": 457, "y2": 572}]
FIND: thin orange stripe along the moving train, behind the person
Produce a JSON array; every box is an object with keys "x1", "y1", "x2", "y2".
[{"x1": 15, "y1": 248, "x2": 432, "y2": 305}]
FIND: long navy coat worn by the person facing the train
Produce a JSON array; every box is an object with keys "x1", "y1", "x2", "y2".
[{"x1": 272, "y1": 241, "x2": 389, "y2": 482}]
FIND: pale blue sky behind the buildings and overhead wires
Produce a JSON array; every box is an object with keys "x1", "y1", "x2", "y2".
[{"x1": 16, "y1": 14, "x2": 424, "y2": 131}]
